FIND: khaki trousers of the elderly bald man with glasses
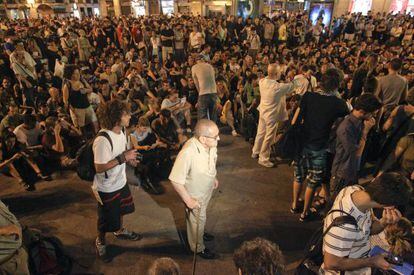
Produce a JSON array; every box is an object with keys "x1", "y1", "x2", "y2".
[{"x1": 185, "y1": 190, "x2": 213, "y2": 253}]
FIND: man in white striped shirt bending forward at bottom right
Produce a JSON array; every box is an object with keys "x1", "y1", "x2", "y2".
[{"x1": 320, "y1": 173, "x2": 411, "y2": 275}]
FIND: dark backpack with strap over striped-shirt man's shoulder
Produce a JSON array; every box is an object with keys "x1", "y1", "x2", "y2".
[{"x1": 295, "y1": 209, "x2": 358, "y2": 275}]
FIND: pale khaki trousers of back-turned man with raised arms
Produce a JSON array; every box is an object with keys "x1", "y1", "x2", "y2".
[{"x1": 252, "y1": 116, "x2": 278, "y2": 161}]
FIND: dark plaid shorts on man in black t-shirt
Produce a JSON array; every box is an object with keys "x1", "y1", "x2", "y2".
[{"x1": 293, "y1": 148, "x2": 327, "y2": 188}]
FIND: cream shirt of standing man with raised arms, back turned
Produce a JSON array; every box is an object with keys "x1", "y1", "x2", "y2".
[{"x1": 258, "y1": 77, "x2": 296, "y2": 121}]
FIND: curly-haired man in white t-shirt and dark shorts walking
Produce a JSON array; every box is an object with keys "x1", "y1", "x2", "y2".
[{"x1": 92, "y1": 100, "x2": 142, "y2": 262}]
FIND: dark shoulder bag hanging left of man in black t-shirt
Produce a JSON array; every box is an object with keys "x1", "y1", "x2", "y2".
[{"x1": 275, "y1": 108, "x2": 303, "y2": 160}]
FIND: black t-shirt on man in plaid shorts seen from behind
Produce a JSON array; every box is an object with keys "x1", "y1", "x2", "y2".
[{"x1": 300, "y1": 92, "x2": 349, "y2": 151}]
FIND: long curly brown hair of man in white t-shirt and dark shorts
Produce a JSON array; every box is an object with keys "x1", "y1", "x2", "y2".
[{"x1": 96, "y1": 99, "x2": 129, "y2": 130}]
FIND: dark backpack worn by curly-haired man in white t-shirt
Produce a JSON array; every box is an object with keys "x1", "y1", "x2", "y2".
[{"x1": 76, "y1": 131, "x2": 114, "y2": 181}]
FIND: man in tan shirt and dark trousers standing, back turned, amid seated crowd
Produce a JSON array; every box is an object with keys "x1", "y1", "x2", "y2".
[{"x1": 191, "y1": 54, "x2": 217, "y2": 122}]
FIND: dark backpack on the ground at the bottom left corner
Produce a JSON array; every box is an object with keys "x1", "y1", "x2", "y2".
[{"x1": 28, "y1": 234, "x2": 73, "y2": 275}]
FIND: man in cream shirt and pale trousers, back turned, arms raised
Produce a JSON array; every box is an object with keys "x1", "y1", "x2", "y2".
[{"x1": 252, "y1": 64, "x2": 296, "y2": 168}]
